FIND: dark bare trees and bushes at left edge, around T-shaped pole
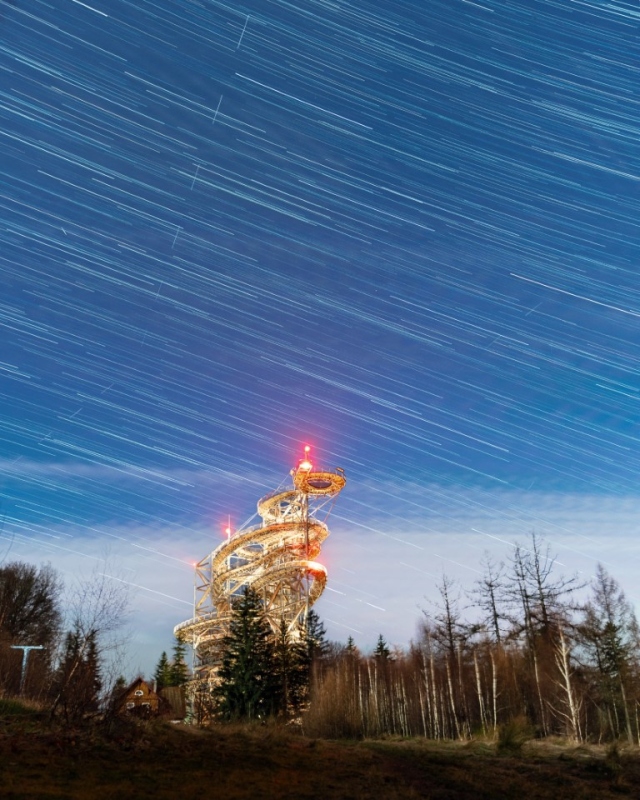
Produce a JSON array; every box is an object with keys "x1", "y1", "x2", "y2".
[{"x1": 0, "y1": 562, "x2": 128, "y2": 724}]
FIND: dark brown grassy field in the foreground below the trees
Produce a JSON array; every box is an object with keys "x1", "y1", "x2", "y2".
[{"x1": 0, "y1": 701, "x2": 640, "y2": 800}]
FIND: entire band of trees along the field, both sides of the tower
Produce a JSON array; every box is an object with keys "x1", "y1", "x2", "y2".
[{"x1": 0, "y1": 535, "x2": 640, "y2": 748}]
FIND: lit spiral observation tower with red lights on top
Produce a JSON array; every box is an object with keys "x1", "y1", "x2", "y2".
[{"x1": 174, "y1": 446, "x2": 346, "y2": 684}]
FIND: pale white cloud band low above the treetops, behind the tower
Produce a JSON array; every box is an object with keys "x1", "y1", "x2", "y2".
[{"x1": 0, "y1": 486, "x2": 640, "y2": 672}]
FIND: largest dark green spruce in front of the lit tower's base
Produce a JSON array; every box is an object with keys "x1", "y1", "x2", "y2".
[{"x1": 213, "y1": 586, "x2": 281, "y2": 720}]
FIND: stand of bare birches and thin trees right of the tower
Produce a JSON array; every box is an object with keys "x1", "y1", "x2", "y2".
[{"x1": 304, "y1": 536, "x2": 640, "y2": 744}]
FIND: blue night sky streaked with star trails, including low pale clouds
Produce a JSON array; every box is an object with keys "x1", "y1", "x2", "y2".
[{"x1": 0, "y1": 0, "x2": 640, "y2": 671}]
